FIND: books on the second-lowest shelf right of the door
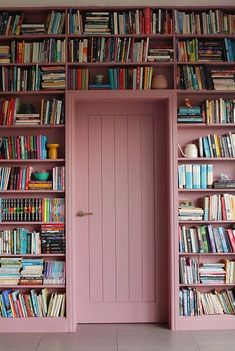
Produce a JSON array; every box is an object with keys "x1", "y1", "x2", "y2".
[{"x1": 179, "y1": 257, "x2": 226, "y2": 285}]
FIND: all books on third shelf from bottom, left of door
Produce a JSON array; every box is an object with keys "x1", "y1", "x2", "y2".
[{"x1": 0, "y1": 224, "x2": 65, "y2": 255}]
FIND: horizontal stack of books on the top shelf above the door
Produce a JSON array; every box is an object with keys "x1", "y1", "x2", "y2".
[{"x1": 84, "y1": 12, "x2": 110, "y2": 34}]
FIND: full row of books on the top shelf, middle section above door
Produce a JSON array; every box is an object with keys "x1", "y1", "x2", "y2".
[{"x1": 68, "y1": 7, "x2": 173, "y2": 34}]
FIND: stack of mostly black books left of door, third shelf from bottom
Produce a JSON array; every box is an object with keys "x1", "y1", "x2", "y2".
[{"x1": 41, "y1": 224, "x2": 65, "y2": 254}]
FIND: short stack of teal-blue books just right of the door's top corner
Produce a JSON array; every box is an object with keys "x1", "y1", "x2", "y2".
[{"x1": 177, "y1": 106, "x2": 203, "y2": 123}]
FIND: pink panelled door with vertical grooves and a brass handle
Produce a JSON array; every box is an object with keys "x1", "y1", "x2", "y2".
[{"x1": 75, "y1": 104, "x2": 167, "y2": 323}]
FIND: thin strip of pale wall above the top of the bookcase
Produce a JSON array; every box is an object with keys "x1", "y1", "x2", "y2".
[{"x1": 0, "y1": 0, "x2": 235, "y2": 7}]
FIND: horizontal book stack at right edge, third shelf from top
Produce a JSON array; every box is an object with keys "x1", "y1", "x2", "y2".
[{"x1": 211, "y1": 68, "x2": 235, "y2": 90}]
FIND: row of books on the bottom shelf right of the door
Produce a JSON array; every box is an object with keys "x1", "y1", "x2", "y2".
[{"x1": 179, "y1": 288, "x2": 235, "y2": 317}]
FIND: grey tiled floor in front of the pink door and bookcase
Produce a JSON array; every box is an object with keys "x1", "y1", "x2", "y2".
[{"x1": 0, "y1": 324, "x2": 235, "y2": 351}]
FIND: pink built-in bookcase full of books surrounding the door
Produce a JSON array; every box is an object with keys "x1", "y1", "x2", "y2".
[{"x1": 0, "y1": 6, "x2": 235, "y2": 332}]
